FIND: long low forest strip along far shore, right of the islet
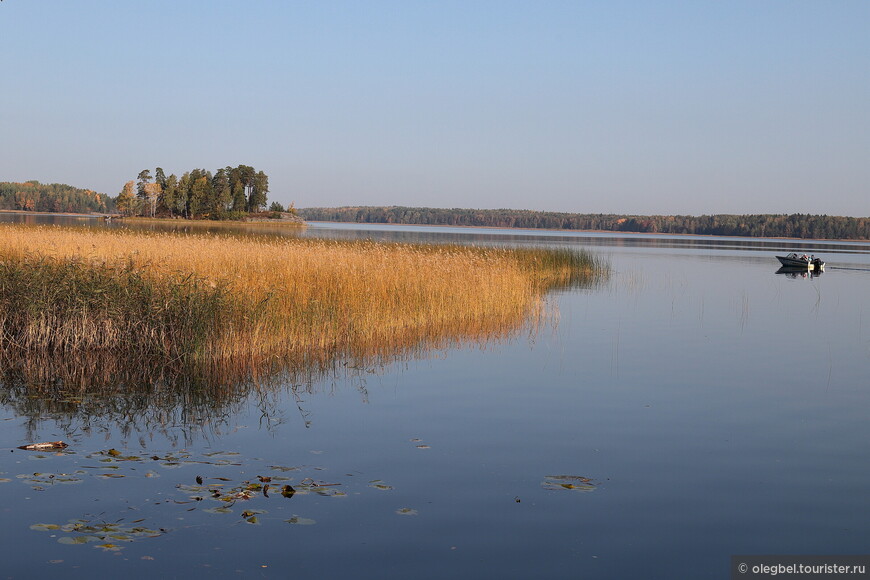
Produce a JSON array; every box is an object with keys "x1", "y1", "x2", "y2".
[{"x1": 299, "y1": 206, "x2": 870, "y2": 240}]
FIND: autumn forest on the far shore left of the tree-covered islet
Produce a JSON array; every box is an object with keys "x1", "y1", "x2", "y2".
[{"x1": 0, "y1": 180, "x2": 115, "y2": 213}]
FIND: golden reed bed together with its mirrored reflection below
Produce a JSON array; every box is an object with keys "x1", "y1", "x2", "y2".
[{"x1": 0, "y1": 225, "x2": 606, "y2": 440}]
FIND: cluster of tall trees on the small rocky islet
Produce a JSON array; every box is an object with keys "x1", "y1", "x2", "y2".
[{"x1": 116, "y1": 165, "x2": 284, "y2": 219}]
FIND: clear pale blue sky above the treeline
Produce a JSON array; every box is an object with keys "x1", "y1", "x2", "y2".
[{"x1": 0, "y1": 0, "x2": 870, "y2": 217}]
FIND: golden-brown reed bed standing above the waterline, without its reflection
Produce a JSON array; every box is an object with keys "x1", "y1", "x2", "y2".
[{"x1": 0, "y1": 225, "x2": 602, "y2": 365}]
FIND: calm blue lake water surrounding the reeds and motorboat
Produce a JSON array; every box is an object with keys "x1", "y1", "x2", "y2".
[{"x1": 0, "y1": 218, "x2": 870, "y2": 579}]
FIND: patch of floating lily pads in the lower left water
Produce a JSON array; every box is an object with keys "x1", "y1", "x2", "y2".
[{"x1": 17, "y1": 447, "x2": 396, "y2": 552}]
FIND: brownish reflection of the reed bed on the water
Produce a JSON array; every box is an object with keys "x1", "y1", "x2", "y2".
[{"x1": 0, "y1": 312, "x2": 556, "y2": 444}]
